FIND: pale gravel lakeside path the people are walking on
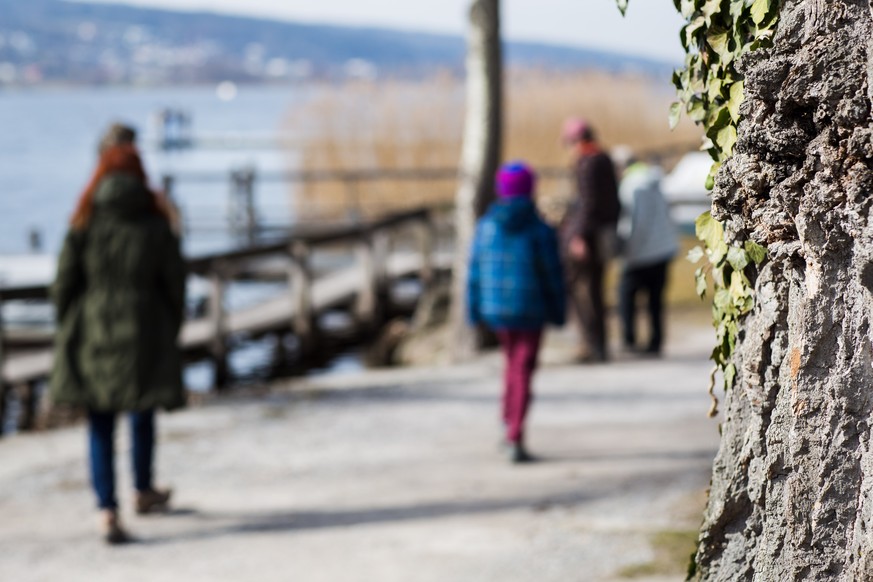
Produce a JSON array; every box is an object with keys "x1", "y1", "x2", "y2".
[{"x1": 0, "y1": 321, "x2": 718, "y2": 582}]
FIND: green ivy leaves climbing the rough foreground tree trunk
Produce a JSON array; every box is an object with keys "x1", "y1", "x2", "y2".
[{"x1": 616, "y1": 0, "x2": 780, "y2": 416}]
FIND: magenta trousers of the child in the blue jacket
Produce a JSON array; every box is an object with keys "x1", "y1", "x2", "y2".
[{"x1": 496, "y1": 329, "x2": 542, "y2": 443}]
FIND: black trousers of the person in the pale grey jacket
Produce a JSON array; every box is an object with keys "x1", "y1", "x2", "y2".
[{"x1": 618, "y1": 261, "x2": 669, "y2": 353}]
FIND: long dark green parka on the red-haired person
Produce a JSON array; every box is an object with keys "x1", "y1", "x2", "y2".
[{"x1": 51, "y1": 174, "x2": 185, "y2": 412}]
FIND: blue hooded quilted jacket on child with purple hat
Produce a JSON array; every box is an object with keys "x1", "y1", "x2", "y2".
[{"x1": 467, "y1": 197, "x2": 565, "y2": 330}]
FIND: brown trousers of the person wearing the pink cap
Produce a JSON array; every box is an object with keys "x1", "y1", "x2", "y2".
[{"x1": 567, "y1": 259, "x2": 607, "y2": 360}]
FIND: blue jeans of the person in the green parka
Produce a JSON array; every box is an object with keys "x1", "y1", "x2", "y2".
[{"x1": 88, "y1": 410, "x2": 155, "y2": 509}]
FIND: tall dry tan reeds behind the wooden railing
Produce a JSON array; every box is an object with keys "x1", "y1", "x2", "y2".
[{"x1": 289, "y1": 71, "x2": 700, "y2": 219}]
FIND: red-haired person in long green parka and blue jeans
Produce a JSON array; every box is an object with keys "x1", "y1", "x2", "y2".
[{"x1": 50, "y1": 124, "x2": 185, "y2": 544}]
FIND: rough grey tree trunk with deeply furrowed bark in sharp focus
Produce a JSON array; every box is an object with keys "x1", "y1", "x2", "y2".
[{"x1": 697, "y1": 0, "x2": 873, "y2": 581}]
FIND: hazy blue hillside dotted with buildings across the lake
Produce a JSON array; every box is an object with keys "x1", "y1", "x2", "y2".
[{"x1": 0, "y1": 0, "x2": 670, "y2": 86}]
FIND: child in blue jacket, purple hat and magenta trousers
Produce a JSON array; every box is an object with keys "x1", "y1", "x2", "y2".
[{"x1": 467, "y1": 162, "x2": 566, "y2": 462}]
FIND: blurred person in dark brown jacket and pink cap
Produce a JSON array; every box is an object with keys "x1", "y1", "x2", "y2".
[{"x1": 561, "y1": 119, "x2": 620, "y2": 362}]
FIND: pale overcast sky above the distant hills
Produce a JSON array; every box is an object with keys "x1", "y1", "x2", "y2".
[{"x1": 76, "y1": 0, "x2": 683, "y2": 64}]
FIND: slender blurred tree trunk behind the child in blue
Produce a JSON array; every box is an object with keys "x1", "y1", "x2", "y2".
[{"x1": 451, "y1": 0, "x2": 503, "y2": 359}]
